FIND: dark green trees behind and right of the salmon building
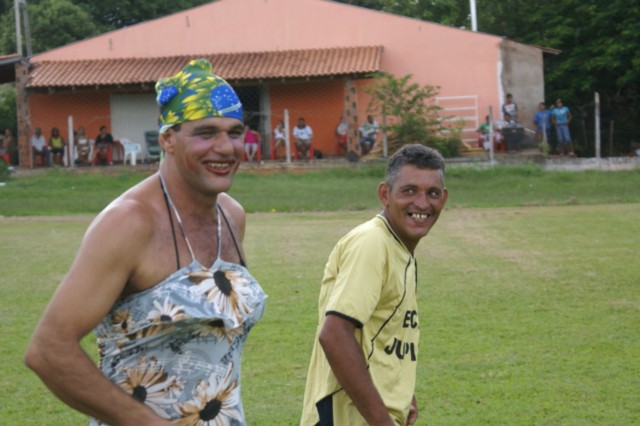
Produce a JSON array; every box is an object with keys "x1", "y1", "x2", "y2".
[{"x1": 336, "y1": 0, "x2": 640, "y2": 153}]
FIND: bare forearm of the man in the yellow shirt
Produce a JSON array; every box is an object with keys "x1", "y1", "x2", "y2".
[{"x1": 319, "y1": 314, "x2": 395, "y2": 426}]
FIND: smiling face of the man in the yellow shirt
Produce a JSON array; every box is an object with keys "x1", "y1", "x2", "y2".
[{"x1": 378, "y1": 164, "x2": 448, "y2": 253}]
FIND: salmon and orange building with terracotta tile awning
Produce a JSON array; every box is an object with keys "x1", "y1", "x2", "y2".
[{"x1": 7, "y1": 0, "x2": 544, "y2": 166}]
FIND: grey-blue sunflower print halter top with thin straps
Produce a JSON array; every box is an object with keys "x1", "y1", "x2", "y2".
[{"x1": 90, "y1": 182, "x2": 267, "y2": 426}]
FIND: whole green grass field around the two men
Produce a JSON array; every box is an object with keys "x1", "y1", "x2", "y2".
[{"x1": 0, "y1": 168, "x2": 640, "y2": 426}]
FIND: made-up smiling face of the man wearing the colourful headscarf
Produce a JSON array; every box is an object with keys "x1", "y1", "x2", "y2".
[{"x1": 162, "y1": 117, "x2": 244, "y2": 195}]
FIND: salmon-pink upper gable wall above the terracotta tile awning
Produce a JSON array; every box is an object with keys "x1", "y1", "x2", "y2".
[{"x1": 33, "y1": 0, "x2": 512, "y2": 114}]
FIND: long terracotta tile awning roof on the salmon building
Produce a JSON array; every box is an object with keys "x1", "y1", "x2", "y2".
[{"x1": 28, "y1": 46, "x2": 383, "y2": 88}]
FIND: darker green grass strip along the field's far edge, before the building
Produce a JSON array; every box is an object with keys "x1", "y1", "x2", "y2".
[{"x1": 0, "y1": 164, "x2": 640, "y2": 216}]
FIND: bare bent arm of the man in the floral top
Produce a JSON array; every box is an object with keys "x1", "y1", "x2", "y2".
[{"x1": 25, "y1": 201, "x2": 170, "y2": 425}]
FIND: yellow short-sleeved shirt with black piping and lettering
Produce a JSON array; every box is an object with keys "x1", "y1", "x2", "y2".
[{"x1": 300, "y1": 215, "x2": 420, "y2": 426}]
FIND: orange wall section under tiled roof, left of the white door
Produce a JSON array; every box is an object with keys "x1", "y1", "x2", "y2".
[{"x1": 29, "y1": 92, "x2": 111, "y2": 142}]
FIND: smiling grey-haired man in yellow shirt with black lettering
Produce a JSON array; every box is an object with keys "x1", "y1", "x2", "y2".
[{"x1": 300, "y1": 144, "x2": 448, "y2": 426}]
